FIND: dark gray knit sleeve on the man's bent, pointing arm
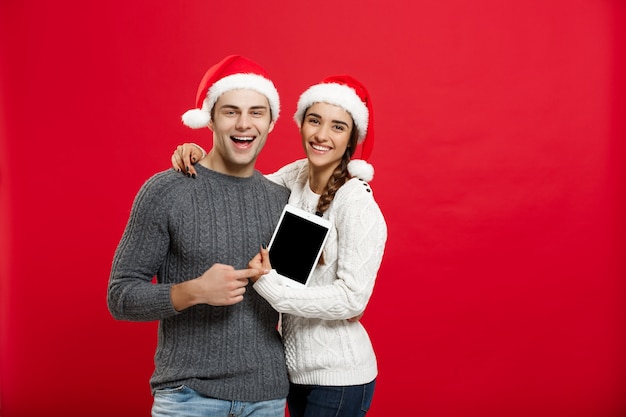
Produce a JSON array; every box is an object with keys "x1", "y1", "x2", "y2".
[{"x1": 107, "y1": 174, "x2": 179, "y2": 321}]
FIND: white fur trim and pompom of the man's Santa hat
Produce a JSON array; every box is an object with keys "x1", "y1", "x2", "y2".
[{"x1": 182, "y1": 74, "x2": 280, "y2": 129}]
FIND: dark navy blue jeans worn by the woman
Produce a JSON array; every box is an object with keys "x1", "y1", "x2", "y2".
[{"x1": 287, "y1": 380, "x2": 376, "y2": 417}]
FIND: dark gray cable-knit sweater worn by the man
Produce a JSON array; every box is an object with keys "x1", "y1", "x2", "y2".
[{"x1": 108, "y1": 165, "x2": 289, "y2": 401}]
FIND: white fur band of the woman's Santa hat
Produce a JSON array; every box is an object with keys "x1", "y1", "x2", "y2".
[{"x1": 293, "y1": 83, "x2": 369, "y2": 143}]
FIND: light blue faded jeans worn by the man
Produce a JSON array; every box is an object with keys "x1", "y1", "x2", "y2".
[{"x1": 152, "y1": 385, "x2": 286, "y2": 417}]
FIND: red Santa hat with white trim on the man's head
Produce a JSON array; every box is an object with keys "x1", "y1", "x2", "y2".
[{"x1": 182, "y1": 55, "x2": 280, "y2": 129}]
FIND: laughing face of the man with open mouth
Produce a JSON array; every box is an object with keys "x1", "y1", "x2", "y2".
[{"x1": 209, "y1": 90, "x2": 274, "y2": 177}]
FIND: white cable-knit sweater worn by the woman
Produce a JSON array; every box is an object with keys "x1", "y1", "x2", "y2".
[{"x1": 254, "y1": 159, "x2": 387, "y2": 386}]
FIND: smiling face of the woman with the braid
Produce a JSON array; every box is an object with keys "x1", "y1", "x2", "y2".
[{"x1": 300, "y1": 103, "x2": 354, "y2": 172}]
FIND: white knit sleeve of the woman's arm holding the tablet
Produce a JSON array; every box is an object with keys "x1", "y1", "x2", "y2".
[{"x1": 254, "y1": 179, "x2": 387, "y2": 320}]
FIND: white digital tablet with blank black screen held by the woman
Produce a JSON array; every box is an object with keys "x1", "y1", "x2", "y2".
[{"x1": 268, "y1": 204, "x2": 332, "y2": 286}]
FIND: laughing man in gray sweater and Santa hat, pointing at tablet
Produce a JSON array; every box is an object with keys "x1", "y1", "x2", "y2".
[{"x1": 108, "y1": 56, "x2": 289, "y2": 417}]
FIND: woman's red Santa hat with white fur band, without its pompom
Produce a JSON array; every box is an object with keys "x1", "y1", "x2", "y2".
[{"x1": 293, "y1": 75, "x2": 374, "y2": 160}]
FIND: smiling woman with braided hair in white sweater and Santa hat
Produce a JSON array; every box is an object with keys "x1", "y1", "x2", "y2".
[{"x1": 172, "y1": 76, "x2": 387, "y2": 417}]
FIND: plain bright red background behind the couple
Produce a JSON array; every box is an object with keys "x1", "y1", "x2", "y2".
[{"x1": 0, "y1": 0, "x2": 626, "y2": 417}]
